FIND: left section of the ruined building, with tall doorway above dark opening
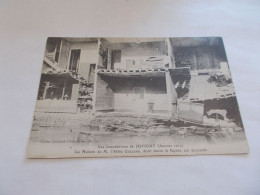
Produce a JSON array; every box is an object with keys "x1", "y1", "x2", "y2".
[{"x1": 36, "y1": 38, "x2": 98, "y2": 113}]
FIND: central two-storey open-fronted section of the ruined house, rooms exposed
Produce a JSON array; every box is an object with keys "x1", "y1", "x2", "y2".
[{"x1": 94, "y1": 38, "x2": 190, "y2": 115}]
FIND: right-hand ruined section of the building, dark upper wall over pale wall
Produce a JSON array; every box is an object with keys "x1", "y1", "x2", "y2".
[{"x1": 171, "y1": 37, "x2": 242, "y2": 126}]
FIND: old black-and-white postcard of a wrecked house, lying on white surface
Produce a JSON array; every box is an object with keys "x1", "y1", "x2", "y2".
[{"x1": 27, "y1": 37, "x2": 249, "y2": 158}]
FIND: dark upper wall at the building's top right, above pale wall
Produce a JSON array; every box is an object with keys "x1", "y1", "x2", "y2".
[{"x1": 170, "y1": 37, "x2": 227, "y2": 71}]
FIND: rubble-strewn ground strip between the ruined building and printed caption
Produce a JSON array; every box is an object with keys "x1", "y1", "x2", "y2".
[{"x1": 31, "y1": 113, "x2": 245, "y2": 144}]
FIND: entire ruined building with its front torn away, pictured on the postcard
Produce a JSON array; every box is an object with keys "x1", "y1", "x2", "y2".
[{"x1": 36, "y1": 37, "x2": 243, "y2": 126}]
